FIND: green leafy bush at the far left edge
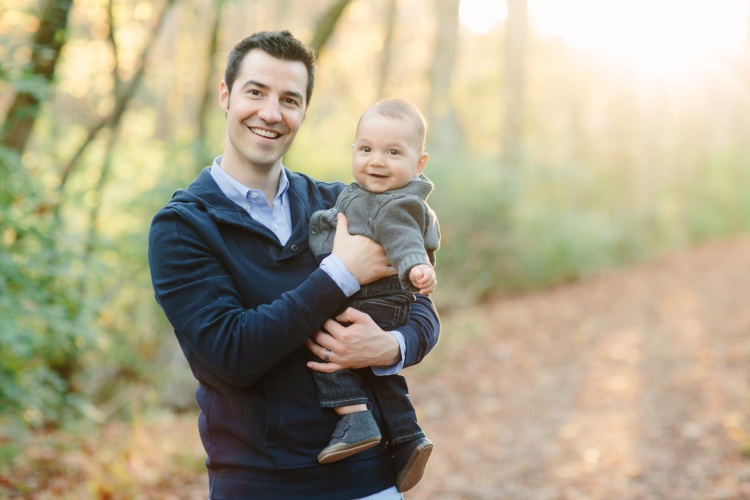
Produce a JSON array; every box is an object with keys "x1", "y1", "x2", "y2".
[{"x1": 0, "y1": 146, "x2": 93, "y2": 425}]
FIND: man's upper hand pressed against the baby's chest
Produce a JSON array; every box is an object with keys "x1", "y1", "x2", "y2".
[{"x1": 331, "y1": 213, "x2": 396, "y2": 285}]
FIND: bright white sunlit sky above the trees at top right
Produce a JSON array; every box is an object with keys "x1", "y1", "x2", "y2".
[{"x1": 460, "y1": 0, "x2": 748, "y2": 76}]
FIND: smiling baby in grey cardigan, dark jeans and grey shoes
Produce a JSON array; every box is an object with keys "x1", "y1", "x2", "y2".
[{"x1": 310, "y1": 99, "x2": 440, "y2": 492}]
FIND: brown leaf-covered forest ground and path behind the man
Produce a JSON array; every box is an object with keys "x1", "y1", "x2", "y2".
[{"x1": 0, "y1": 237, "x2": 750, "y2": 500}]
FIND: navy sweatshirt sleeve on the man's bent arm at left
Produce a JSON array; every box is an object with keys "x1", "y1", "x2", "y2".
[{"x1": 148, "y1": 208, "x2": 345, "y2": 387}]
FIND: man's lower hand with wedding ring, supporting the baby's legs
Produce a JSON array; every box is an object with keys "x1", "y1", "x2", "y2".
[{"x1": 306, "y1": 307, "x2": 401, "y2": 373}]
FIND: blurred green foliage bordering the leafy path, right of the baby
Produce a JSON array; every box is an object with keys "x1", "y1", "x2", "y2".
[{"x1": 428, "y1": 151, "x2": 750, "y2": 310}]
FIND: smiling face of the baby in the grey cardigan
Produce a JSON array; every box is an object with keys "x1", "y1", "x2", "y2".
[{"x1": 352, "y1": 113, "x2": 427, "y2": 193}]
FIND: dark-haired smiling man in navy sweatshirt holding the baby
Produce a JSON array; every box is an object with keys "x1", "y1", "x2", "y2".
[{"x1": 149, "y1": 31, "x2": 440, "y2": 500}]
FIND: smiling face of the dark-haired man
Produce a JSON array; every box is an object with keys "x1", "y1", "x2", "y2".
[{"x1": 219, "y1": 49, "x2": 307, "y2": 172}]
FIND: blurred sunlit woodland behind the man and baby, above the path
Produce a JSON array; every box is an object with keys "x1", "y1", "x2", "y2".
[{"x1": 0, "y1": 0, "x2": 750, "y2": 498}]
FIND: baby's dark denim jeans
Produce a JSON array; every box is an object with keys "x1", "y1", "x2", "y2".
[{"x1": 313, "y1": 277, "x2": 424, "y2": 444}]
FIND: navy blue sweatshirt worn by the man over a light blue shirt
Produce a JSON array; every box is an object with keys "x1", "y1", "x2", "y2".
[{"x1": 148, "y1": 168, "x2": 440, "y2": 500}]
